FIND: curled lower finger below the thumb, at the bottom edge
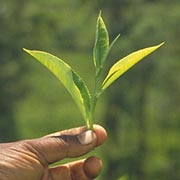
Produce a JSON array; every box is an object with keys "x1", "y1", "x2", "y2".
[{"x1": 49, "y1": 157, "x2": 102, "y2": 180}]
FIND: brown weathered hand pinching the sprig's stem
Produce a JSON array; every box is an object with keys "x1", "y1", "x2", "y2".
[{"x1": 0, "y1": 125, "x2": 107, "y2": 180}]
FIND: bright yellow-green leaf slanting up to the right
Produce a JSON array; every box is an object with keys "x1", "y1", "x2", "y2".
[{"x1": 102, "y1": 43, "x2": 164, "y2": 91}]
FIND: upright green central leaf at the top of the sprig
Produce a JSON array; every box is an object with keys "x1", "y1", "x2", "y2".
[{"x1": 93, "y1": 12, "x2": 109, "y2": 72}]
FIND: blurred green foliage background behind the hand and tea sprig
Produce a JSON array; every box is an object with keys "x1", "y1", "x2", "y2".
[{"x1": 0, "y1": 0, "x2": 180, "y2": 180}]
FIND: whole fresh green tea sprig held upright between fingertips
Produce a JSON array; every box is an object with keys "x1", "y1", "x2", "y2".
[{"x1": 24, "y1": 12, "x2": 164, "y2": 129}]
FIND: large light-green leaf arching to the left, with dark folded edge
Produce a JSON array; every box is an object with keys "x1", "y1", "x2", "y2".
[{"x1": 24, "y1": 49, "x2": 91, "y2": 126}]
